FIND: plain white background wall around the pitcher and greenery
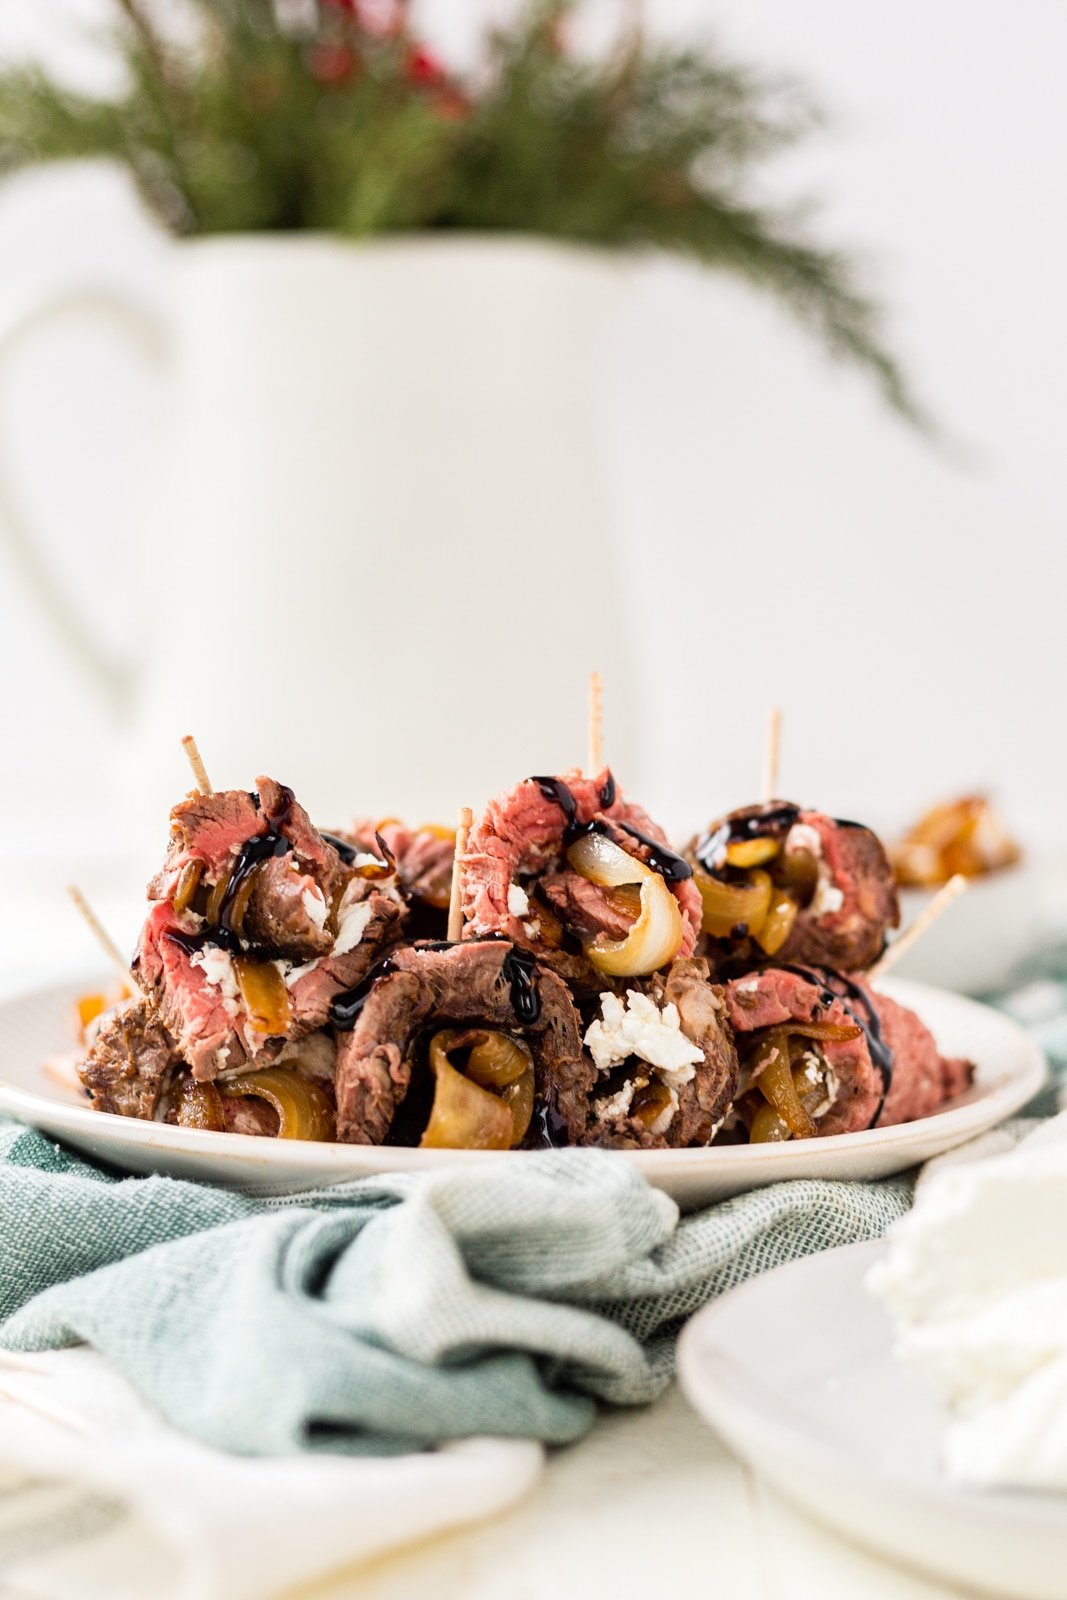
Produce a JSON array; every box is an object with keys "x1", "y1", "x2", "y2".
[{"x1": 0, "y1": 0, "x2": 1067, "y2": 896}]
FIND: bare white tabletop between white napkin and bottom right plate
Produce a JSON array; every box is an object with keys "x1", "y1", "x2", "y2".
[{"x1": 301, "y1": 1389, "x2": 963, "y2": 1600}]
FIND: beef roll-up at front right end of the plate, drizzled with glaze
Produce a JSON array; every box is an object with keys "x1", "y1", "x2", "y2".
[{"x1": 726, "y1": 966, "x2": 973, "y2": 1144}]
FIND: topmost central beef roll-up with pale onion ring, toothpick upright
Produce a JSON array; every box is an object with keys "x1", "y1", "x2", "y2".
[{"x1": 462, "y1": 768, "x2": 701, "y2": 995}]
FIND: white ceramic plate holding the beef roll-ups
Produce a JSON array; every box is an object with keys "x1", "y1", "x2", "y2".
[{"x1": 0, "y1": 978, "x2": 1045, "y2": 1208}]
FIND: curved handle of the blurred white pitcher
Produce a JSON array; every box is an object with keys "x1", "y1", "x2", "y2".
[{"x1": 0, "y1": 283, "x2": 166, "y2": 710}]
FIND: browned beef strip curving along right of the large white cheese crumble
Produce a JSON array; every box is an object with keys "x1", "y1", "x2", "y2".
[{"x1": 585, "y1": 957, "x2": 737, "y2": 1150}]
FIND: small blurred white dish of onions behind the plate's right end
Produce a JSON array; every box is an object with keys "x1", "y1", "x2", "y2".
[{"x1": 896, "y1": 859, "x2": 1046, "y2": 994}]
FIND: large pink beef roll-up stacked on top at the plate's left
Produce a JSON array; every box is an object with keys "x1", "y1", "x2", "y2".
[{"x1": 134, "y1": 778, "x2": 403, "y2": 1082}]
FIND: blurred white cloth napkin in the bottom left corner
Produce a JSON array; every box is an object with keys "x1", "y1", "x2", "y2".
[{"x1": 0, "y1": 1349, "x2": 542, "y2": 1600}]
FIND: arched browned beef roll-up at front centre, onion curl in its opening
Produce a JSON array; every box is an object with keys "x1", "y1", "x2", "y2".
[{"x1": 333, "y1": 939, "x2": 595, "y2": 1150}]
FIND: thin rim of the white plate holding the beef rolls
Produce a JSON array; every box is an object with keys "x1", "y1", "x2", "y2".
[{"x1": 0, "y1": 973, "x2": 1048, "y2": 1187}]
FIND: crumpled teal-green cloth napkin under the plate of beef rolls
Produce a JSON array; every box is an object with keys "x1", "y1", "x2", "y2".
[{"x1": 0, "y1": 1125, "x2": 912, "y2": 1456}]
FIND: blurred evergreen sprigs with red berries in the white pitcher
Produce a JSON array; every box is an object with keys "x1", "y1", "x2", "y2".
[{"x1": 0, "y1": 0, "x2": 923, "y2": 422}]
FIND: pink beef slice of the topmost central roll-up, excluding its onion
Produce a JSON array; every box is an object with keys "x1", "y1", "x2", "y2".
[{"x1": 462, "y1": 768, "x2": 701, "y2": 992}]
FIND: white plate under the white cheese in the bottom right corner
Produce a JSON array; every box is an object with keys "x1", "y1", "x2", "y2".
[{"x1": 678, "y1": 1242, "x2": 1067, "y2": 1600}]
